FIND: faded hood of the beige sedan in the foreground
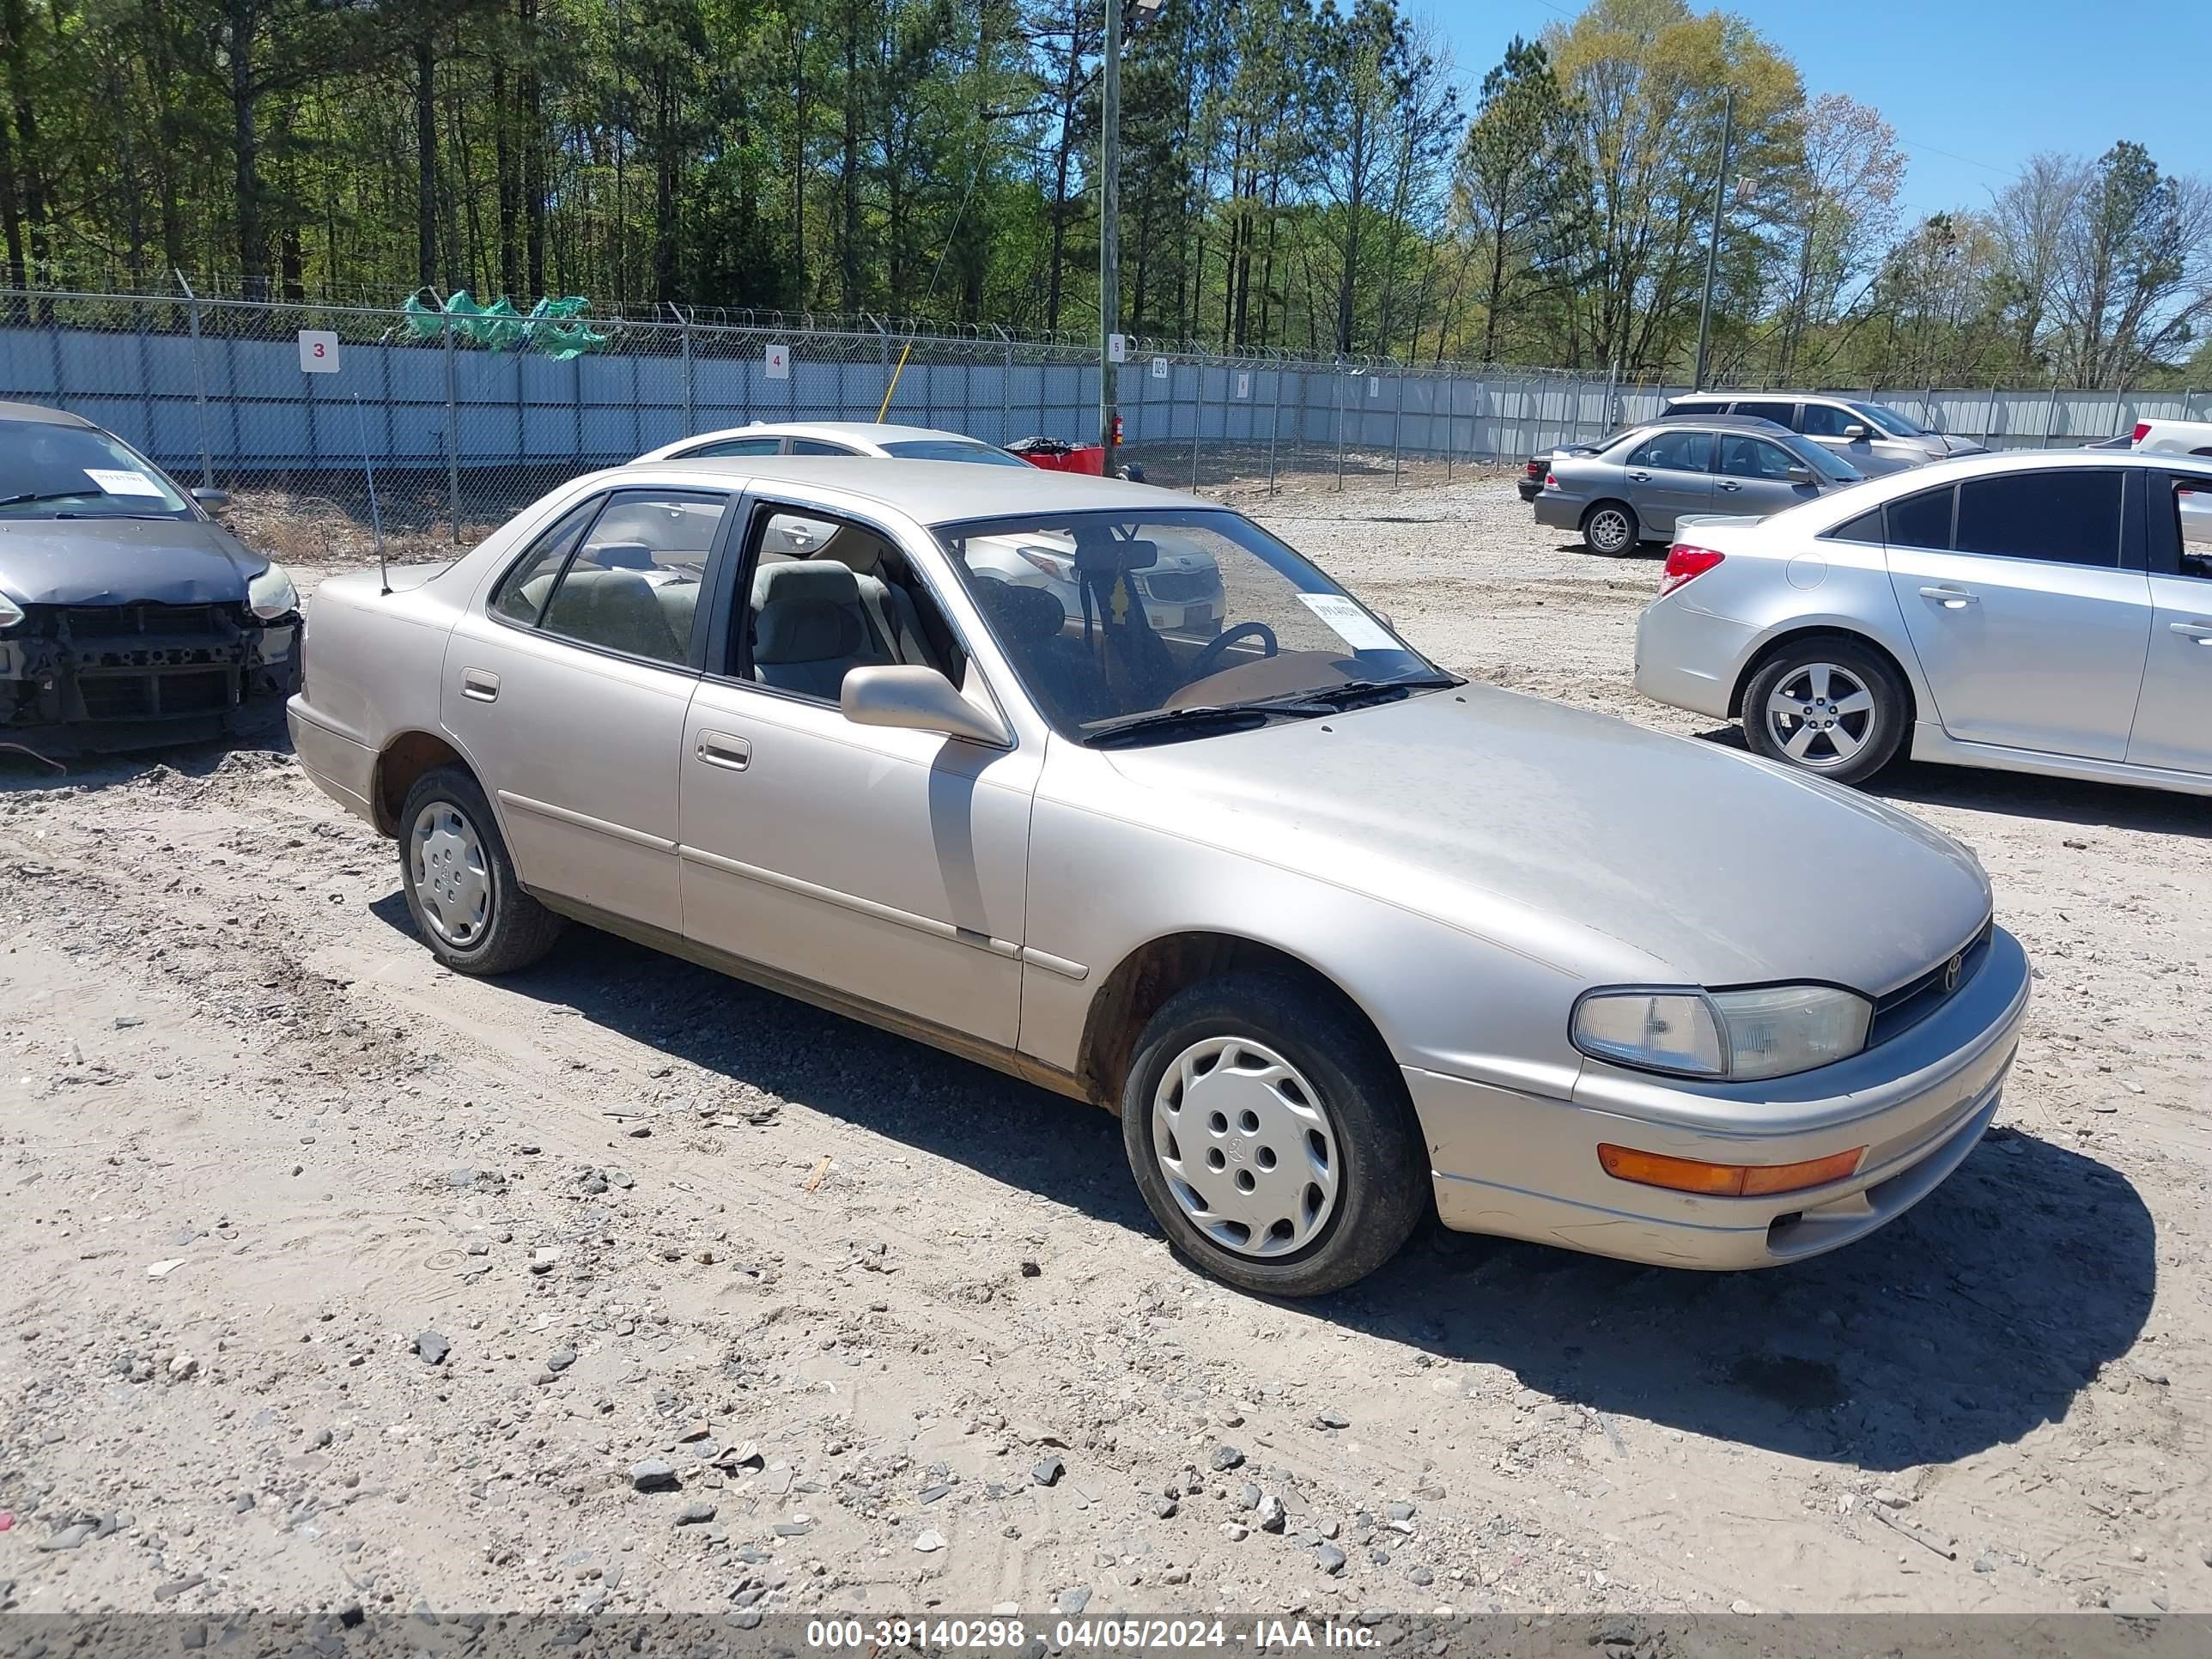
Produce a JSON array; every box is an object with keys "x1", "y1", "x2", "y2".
[{"x1": 1106, "y1": 686, "x2": 1989, "y2": 995}]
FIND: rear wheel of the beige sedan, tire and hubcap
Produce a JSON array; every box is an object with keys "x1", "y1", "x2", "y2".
[{"x1": 400, "y1": 765, "x2": 562, "y2": 973}]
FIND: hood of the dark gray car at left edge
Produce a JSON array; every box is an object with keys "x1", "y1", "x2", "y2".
[{"x1": 0, "y1": 518, "x2": 268, "y2": 604}]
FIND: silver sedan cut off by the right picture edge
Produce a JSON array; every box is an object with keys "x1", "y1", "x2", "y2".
[{"x1": 1637, "y1": 449, "x2": 2212, "y2": 794}]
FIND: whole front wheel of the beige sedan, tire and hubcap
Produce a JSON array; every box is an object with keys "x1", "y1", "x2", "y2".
[{"x1": 1121, "y1": 973, "x2": 1429, "y2": 1297}]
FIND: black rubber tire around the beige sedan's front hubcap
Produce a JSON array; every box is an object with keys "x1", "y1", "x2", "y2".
[{"x1": 1121, "y1": 971, "x2": 1429, "y2": 1297}]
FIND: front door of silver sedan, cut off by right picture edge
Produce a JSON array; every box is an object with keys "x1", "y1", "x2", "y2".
[{"x1": 2128, "y1": 471, "x2": 2212, "y2": 772}]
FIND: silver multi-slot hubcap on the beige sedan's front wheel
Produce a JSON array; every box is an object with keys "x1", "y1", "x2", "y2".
[{"x1": 1152, "y1": 1037, "x2": 1343, "y2": 1256}]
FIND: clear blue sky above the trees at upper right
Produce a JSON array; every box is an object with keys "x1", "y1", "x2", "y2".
[{"x1": 1407, "y1": 0, "x2": 2212, "y2": 216}]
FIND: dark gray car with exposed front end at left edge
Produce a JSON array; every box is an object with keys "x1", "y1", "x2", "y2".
[{"x1": 0, "y1": 403, "x2": 299, "y2": 757}]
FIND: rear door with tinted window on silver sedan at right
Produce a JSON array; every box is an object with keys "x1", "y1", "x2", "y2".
[{"x1": 1887, "y1": 467, "x2": 2150, "y2": 761}]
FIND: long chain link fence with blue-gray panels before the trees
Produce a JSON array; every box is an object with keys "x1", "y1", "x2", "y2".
[{"x1": 0, "y1": 292, "x2": 2212, "y2": 562}]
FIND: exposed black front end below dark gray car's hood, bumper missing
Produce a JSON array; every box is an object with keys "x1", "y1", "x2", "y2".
[{"x1": 0, "y1": 604, "x2": 301, "y2": 754}]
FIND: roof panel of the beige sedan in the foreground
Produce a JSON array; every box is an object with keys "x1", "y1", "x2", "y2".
[{"x1": 615, "y1": 456, "x2": 1203, "y2": 525}]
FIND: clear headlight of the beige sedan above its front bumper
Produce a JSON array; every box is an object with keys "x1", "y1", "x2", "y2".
[{"x1": 1571, "y1": 984, "x2": 1874, "y2": 1082}]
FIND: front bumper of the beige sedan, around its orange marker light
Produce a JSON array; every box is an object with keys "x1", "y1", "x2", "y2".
[{"x1": 1405, "y1": 929, "x2": 2028, "y2": 1270}]
